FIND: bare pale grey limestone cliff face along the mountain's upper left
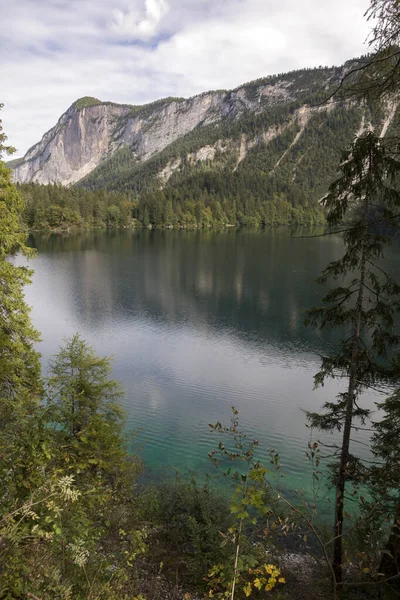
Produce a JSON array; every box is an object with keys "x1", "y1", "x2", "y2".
[{"x1": 14, "y1": 80, "x2": 291, "y2": 185}]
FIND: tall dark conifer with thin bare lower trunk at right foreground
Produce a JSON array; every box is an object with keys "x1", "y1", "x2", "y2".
[{"x1": 307, "y1": 132, "x2": 400, "y2": 584}]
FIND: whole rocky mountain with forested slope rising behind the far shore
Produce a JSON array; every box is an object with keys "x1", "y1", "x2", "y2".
[{"x1": 10, "y1": 61, "x2": 400, "y2": 226}]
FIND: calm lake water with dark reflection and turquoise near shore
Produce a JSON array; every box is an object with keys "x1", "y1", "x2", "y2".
[{"x1": 19, "y1": 229, "x2": 400, "y2": 502}]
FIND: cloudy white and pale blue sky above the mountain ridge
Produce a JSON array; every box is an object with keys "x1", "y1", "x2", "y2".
[{"x1": 0, "y1": 0, "x2": 370, "y2": 157}]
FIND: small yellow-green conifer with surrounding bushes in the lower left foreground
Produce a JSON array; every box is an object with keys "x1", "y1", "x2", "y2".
[{"x1": 0, "y1": 336, "x2": 146, "y2": 600}]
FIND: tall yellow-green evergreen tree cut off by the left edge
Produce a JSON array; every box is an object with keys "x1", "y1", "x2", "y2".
[{"x1": 0, "y1": 105, "x2": 41, "y2": 517}]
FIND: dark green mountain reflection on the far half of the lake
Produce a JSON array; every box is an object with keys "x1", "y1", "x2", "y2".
[{"x1": 33, "y1": 230, "x2": 341, "y2": 351}]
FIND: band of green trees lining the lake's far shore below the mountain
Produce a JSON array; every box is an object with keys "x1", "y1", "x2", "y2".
[{"x1": 19, "y1": 178, "x2": 324, "y2": 230}]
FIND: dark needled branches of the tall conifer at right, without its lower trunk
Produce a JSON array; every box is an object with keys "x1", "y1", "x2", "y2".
[{"x1": 307, "y1": 132, "x2": 400, "y2": 408}]
